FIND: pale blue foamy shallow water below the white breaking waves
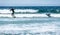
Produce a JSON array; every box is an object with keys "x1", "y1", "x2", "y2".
[{"x1": 0, "y1": 8, "x2": 60, "y2": 35}]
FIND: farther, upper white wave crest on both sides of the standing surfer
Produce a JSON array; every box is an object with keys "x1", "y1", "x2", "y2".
[{"x1": 0, "y1": 9, "x2": 38, "y2": 13}]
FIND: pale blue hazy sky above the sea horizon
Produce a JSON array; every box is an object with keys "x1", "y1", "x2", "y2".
[{"x1": 0, "y1": 0, "x2": 60, "y2": 6}]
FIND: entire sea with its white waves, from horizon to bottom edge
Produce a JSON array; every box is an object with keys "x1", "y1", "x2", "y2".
[{"x1": 0, "y1": 6, "x2": 60, "y2": 35}]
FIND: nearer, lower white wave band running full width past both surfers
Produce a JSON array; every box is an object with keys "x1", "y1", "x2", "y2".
[{"x1": 0, "y1": 14, "x2": 60, "y2": 18}]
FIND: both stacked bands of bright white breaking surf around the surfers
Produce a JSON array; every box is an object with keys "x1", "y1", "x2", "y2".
[{"x1": 0, "y1": 9, "x2": 60, "y2": 17}]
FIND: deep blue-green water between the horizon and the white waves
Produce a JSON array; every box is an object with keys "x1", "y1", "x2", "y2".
[{"x1": 0, "y1": 6, "x2": 60, "y2": 13}]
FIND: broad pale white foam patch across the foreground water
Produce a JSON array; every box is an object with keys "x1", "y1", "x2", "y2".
[{"x1": 0, "y1": 23, "x2": 56, "y2": 34}]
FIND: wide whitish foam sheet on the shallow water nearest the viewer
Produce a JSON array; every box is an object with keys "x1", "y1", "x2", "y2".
[{"x1": 0, "y1": 24, "x2": 56, "y2": 33}]
